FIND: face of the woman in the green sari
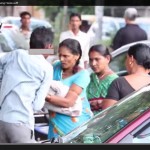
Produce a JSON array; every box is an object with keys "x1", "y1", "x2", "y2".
[{"x1": 89, "y1": 51, "x2": 110, "y2": 73}]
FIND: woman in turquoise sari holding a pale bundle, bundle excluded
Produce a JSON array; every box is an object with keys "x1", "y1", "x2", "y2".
[{"x1": 46, "y1": 39, "x2": 93, "y2": 139}]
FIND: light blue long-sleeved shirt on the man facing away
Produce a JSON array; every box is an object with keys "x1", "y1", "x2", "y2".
[{"x1": 0, "y1": 49, "x2": 53, "y2": 130}]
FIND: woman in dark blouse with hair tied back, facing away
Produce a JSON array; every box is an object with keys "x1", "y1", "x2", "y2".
[{"x1": 101, "y1": 43, "x2": 150, "y2": 109}]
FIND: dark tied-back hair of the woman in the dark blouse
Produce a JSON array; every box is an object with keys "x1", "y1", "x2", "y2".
[{"x1": 128, "y1": 43, "x2": 150, "y2": 69}]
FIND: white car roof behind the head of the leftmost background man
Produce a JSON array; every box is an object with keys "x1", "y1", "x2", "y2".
[{"x1": 1, "y1": 16, "x2": 54, "y2": 31}]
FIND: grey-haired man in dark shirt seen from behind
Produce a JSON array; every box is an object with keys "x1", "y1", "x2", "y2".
[{"x1": 112, "y1": 8, "x2": 147, "y2": 50}]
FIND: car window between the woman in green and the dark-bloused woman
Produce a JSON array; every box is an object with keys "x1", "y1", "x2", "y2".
[{"x1": 109, "y1": 52, "x2": 127, "y2": 72}]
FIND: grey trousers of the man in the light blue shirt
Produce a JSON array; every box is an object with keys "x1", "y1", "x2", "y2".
[{"x1": 0, "y1": 120, "x2": 36, "y2": 143}]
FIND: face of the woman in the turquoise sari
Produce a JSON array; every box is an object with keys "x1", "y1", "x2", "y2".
[{"x1": 58, "y1": 46, "x2": 79, "y2": 69}]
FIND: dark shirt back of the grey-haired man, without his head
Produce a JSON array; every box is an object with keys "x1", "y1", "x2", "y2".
[{"x1": 113, "y1": 24, "x2": 147, "y2": 50}]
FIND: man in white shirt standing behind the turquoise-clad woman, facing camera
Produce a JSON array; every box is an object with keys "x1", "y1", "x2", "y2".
[{"x1": 59, "y1": 13, "x2": 90, "y2": 68}]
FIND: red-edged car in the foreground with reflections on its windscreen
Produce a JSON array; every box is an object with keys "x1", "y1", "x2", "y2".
[{"x1": 59, "y1": 85, "x2": 150, "y2": 144}]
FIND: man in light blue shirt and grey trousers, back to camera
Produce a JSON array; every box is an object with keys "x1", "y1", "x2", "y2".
[{"x1": 0, "y1": 27, "x2": 53, "y2": 143}]
